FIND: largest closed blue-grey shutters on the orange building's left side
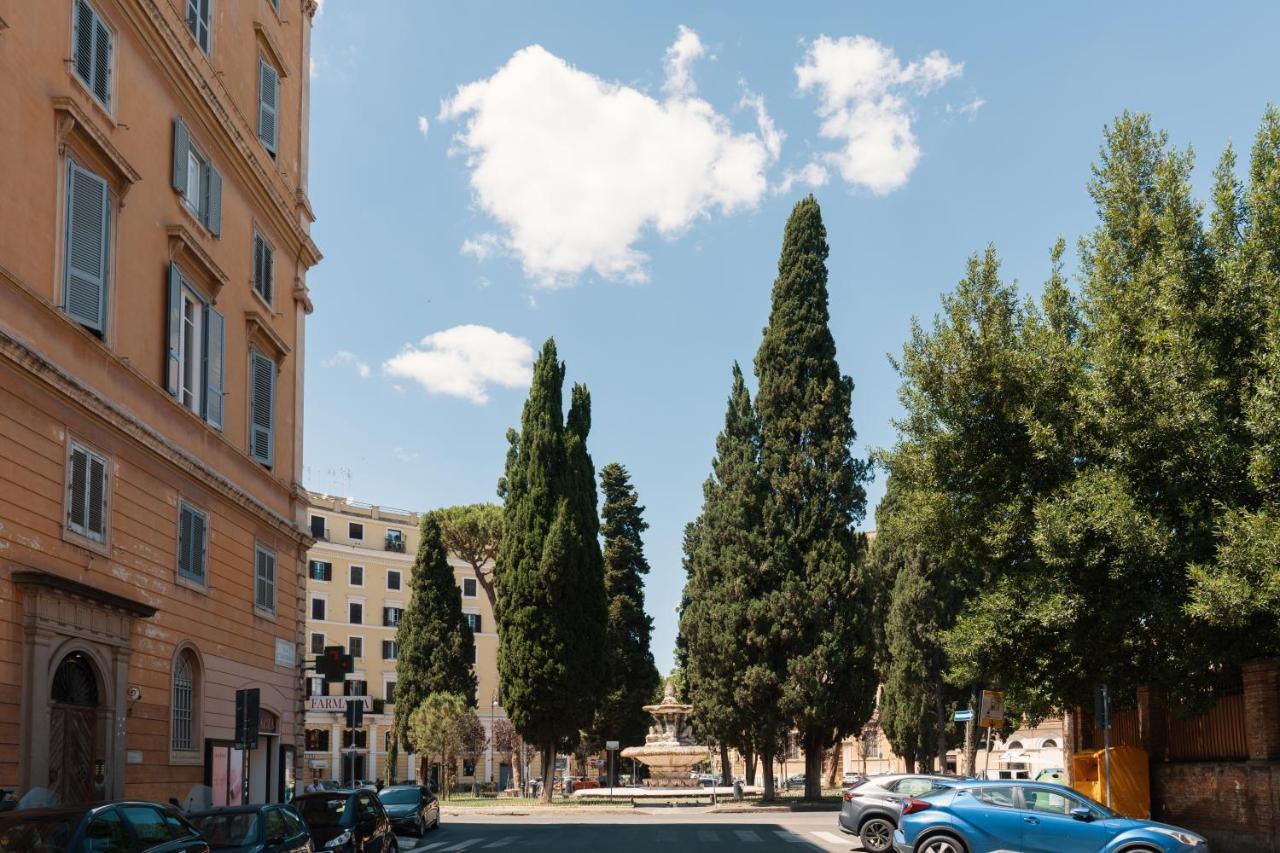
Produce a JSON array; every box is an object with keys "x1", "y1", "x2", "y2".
[{"x1": 63, "y1": 163, "x2": 110, "y2": 332}]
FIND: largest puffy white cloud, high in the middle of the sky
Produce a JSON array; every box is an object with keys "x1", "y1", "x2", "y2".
[{"x1": 440, "y1": 28, "x2": 781, "y2": 287}]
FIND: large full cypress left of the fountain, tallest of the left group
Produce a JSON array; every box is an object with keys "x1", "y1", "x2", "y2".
[{"x1": 494, "y1": 339, "x2": 605, "y2": 800}]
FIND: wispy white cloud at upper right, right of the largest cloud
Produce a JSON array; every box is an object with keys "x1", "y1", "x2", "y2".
[{"x1": 795, "y1": 36, "x2": 964, "y2": 195}]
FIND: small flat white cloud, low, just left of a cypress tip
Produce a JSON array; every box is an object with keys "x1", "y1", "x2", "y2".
[{"x1": 383, "y1": 325, "x2": 534, "y2": 405}]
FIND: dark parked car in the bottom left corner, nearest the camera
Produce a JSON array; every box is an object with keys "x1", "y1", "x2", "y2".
[{"x1": 0, "y1": 800, "x2": 209, "y2": 853}]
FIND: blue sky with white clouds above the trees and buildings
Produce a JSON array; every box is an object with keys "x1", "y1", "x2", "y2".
[{"x1": 306, "y1": 0, "x2": 1280, "y2": 671}]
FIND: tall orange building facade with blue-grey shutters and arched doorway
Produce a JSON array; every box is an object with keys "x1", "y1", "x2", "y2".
[{"x1": 0, "y1": 0, "x2": 320, "y2": 803}]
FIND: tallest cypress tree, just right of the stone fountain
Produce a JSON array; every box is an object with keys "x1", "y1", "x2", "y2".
[{"x1": 755, "y1": 196, "x2": 876, "y2": 798}]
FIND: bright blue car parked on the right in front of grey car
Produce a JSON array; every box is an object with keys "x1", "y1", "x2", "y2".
[{"x1": 893, "y1": 780, "x2": 1208, "y2": 853}]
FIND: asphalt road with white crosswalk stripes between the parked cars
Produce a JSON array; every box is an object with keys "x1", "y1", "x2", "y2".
[{"x1": 399, "y1": 809, "x2": 861, "y2": 853}]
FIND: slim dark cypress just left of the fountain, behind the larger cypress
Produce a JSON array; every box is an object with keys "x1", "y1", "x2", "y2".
[{"x1": 593, "y1": 462, "x2": 662, "y2": 745}]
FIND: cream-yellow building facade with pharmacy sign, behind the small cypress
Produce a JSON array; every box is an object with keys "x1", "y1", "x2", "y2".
[{"x1": 302, "y1": 493, "x2": 511, "y2": 788}]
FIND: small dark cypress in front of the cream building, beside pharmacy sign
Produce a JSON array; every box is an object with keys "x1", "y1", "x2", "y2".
[{"x1": 396, "y1": 515, "x2": 476, "y2": 747}]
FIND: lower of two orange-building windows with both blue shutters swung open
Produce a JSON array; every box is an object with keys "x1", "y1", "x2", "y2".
[{"x1": 165, "y1": 263, "x2": 225, "y2": 429}]
